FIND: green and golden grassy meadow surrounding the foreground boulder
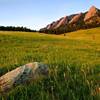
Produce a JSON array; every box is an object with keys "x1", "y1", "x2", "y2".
[{"x1": 0, "y1": 28, "x2": 100, "y2": 100}]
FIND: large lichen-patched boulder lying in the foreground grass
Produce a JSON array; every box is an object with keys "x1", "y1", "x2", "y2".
[{"x1": 0, "y1": 62, "x2": 48, "y2": 92}]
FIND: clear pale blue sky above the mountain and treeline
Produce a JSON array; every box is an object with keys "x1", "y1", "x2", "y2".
[{"x1": 0, "y1": 0, "x2": 100, "y2": 29}]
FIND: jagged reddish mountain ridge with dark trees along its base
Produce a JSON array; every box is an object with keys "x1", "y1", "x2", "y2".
[{"x1": 40, "y1": 6, "x2": 100, "y2": 34}]
